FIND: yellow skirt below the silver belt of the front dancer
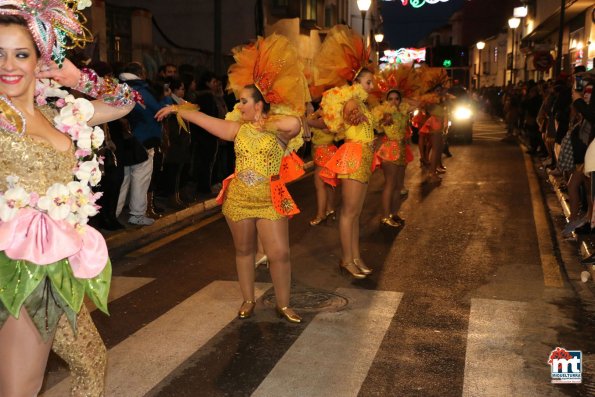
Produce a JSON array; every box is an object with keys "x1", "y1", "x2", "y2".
[{"x1": 222, "y1": 177, "x2": 284, "y2": 222}]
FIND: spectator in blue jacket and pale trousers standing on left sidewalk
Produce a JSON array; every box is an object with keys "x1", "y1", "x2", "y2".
[{"x1": 116, "y1": 62, "x2": 161, "y2": 225}]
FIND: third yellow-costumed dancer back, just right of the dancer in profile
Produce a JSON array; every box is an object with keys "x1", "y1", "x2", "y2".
[{"x1": 372, "y1": 64, "x2": 419, "y2": 228}]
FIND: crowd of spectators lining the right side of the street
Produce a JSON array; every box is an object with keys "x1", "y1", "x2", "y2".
[{"x1": 478, "y1": 65, "x2": 595, "y2": 256}]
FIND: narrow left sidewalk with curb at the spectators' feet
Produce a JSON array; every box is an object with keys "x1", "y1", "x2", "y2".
[{"x1": 99, "y1": 161, "x2": 314, "y2": 258}]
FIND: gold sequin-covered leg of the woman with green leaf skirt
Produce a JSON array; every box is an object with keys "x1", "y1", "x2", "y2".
[{"x1": 52, "y1": 305, "x2": 107, "y2": 397}]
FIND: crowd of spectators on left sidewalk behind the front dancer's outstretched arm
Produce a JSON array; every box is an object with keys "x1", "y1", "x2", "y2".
[{"x1": 90, "y1": 58, "x2": 235, "y2": 230}]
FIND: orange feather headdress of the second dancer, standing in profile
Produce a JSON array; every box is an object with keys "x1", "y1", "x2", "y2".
[{"x1": 314, "y1": 25, "x2": 375, "y2": 87}]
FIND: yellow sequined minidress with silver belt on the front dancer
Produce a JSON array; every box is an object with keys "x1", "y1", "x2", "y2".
[{"x1": 222, "y1": 123, "x2": 285, "y2": 222}]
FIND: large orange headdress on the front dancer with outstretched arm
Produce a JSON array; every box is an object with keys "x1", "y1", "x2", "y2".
[{"x1": 228, "y1": 34, "x2": 310, "y2": 113}]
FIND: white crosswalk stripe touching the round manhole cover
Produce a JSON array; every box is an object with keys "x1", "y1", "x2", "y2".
[{"x1": 252, "y1": 289, "x2": 403, "y2": 397}]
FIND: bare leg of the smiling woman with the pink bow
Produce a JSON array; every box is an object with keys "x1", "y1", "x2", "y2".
[{"x1": 0, "y1": 307, "x2": 54, "y2": 397}]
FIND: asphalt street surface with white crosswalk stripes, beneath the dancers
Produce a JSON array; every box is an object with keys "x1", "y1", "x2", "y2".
[{"x1": 43, "y1": 115, "x2": 595, "y2": 397}]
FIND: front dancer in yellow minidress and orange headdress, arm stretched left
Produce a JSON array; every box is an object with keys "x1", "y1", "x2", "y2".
[{"x1": 156, "y1": 34, "x2": 309, "y2": 323}]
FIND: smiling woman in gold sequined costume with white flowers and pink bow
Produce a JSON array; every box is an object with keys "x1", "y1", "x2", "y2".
[{"x1": 0, "y1": 0, "x2": 135, "y2": 396}]
